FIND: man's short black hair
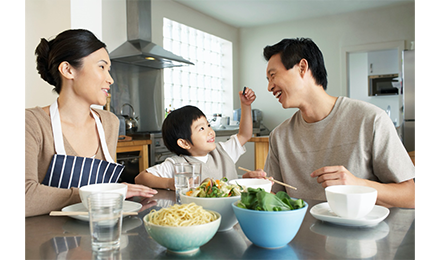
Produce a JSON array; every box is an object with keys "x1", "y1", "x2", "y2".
[{"x1": 263, "y1": 38, "x2": 327, "y2": 90}]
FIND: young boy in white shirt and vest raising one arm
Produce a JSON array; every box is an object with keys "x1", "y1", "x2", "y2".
[{"x1": 135, "y1": 88, "x2": 256, "y2": 190}]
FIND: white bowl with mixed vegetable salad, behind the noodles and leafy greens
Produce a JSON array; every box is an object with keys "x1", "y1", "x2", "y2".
[{"x1": 180, "y1": 178, "x2": 246, "y2": 232}]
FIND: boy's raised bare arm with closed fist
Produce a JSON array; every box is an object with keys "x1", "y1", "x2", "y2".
[{"x1": 237, "y1": 88, "x2": 256, "y2": 146}]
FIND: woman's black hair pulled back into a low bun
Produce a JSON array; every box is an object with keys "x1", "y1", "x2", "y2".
[{"x1": 35, "y1": 29, "x2": 106, "y2": 94}]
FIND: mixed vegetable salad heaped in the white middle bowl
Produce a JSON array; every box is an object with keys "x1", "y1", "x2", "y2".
[{"x1": 186, "y1": 177, "x2": 246, "y2": 198}]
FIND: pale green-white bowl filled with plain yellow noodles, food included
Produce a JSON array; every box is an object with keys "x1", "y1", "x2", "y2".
[{"x1": 143, "y1": 203, "x2": 221, "y2": 254}]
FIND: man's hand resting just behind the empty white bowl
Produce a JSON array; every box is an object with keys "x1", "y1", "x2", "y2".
[{"x1": 310, "y1": 166, "x2": 366, "y2": 188}]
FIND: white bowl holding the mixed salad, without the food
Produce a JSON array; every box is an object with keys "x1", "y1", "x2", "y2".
[{"x1": 180, "y1": 189, "x2": 241, "y2": 232}]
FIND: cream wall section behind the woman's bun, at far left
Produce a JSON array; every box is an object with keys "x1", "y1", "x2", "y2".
[{"x1": 24, "y1": 0, "x2": 70, "y2": 108}]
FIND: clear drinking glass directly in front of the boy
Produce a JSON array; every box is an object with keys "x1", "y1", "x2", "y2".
[{"x1": 174, "y1": 163, "x2": 202, "y2": 204}]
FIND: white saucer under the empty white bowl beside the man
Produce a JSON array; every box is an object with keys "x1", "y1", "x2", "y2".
[{"x1": 310, "y1": 202, "x2": 390, "y2": 227}]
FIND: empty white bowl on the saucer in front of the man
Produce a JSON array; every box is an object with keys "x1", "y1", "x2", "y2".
[{"x1": 325, "y1": 185, "x2": 377, "y2": 219}]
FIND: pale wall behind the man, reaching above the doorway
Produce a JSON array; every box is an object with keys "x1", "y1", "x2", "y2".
[{"x1": 239, "y1": 3, "x2": 415, "y2": 129}]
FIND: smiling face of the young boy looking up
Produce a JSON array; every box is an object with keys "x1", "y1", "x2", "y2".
[{"x1": 185, "y1": 116, "x2": 215, "y2": 156}]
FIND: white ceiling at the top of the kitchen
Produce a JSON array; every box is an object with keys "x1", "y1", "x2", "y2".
[{"x1": 174, "y1": 0, "x2": 415, "y2": 27}]
